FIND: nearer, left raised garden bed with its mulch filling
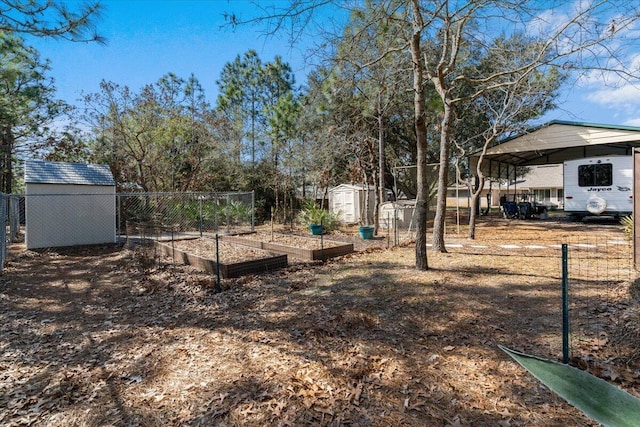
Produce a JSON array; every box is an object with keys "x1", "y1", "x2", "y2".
[{"x1": 155, "y1": 239, "x2": 287, "y2": 279}]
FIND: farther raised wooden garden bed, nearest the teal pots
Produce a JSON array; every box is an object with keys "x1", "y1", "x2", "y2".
[{"x1": 221, "y1": 233, "x2": 353, "y2": 261}]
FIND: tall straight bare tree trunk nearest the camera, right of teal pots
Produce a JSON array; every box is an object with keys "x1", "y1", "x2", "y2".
[{"x1": 411, "y1": 0, "x2": 429, "y2": 270}]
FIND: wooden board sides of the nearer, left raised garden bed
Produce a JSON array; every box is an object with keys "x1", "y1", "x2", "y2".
[{"x1": 154, "y1": 242, "x2": 288, "y2": 279}]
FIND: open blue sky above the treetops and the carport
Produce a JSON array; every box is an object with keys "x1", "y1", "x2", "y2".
[{"x1": 29, "y1": 0, "x2": 640, "y2": 126}]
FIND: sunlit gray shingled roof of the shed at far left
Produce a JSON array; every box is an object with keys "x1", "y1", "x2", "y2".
[{"x1": 24, "y1": 160, "x2": 116, "y2": 186}]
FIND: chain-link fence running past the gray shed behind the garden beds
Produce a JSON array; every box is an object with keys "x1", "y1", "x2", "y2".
[{"x1": 0, "y1": 192, "x2": 255, "y2": 271}]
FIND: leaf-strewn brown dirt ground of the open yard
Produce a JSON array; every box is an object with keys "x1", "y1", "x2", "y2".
[{"x1": 0, "y1": 218, "x2": 640, "y2": 427}]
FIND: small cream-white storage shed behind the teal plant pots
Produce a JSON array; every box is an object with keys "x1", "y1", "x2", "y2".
[{"x1": 329, "y1": 184, "x2": 375, "y2": 224}]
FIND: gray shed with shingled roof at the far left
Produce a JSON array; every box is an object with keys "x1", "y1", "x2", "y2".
[{"x1": 24, "y1": 160, "x2": 116, "y2": 249}]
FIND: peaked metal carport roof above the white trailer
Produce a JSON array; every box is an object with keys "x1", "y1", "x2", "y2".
[{"x1": 471, "y1": 120, "x2": 640, "y2": 177}]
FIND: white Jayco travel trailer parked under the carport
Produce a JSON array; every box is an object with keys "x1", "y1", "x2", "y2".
[{"x1": 564, "y1": 156, "x2": 633, "y2": 218}]
